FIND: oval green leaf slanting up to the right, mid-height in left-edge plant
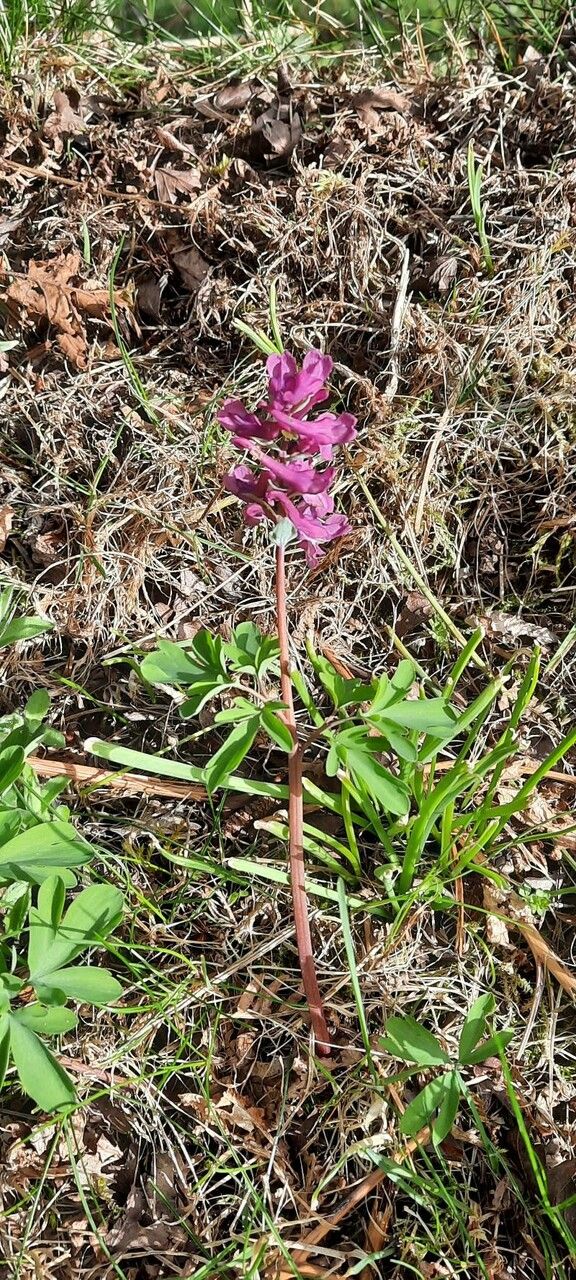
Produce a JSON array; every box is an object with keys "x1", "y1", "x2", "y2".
[{"x1": 29, "y1": 884, "x2": 123, "y2": 989}]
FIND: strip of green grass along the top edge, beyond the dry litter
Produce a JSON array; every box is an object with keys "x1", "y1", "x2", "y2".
[{"x1": 0, "y1": 0, "x2": 568, "y2": 73}]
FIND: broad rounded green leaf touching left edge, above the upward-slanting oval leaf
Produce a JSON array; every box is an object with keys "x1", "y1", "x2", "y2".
[{"x1": 0, "y1": 822, "x2": 93, "y2": 883}]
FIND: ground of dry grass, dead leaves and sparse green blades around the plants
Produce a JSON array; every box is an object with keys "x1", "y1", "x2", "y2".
[{"x1": 0, "y1": 17, "x2": 576, "y2": 1280}]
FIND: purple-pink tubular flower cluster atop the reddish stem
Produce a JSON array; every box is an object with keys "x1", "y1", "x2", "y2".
[{"x1": 218, "y1": 351, "x2": 356, "y2": 564}]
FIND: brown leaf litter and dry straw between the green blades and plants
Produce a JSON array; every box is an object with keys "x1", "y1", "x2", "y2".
[{"x1": 0, "y1": 27, "x2": 576, "y2": 1280}]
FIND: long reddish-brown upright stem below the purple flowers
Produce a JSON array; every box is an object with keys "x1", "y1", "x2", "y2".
[{"x1": 276, "y1": 547, "x2": 330, "y2": 1055}]
